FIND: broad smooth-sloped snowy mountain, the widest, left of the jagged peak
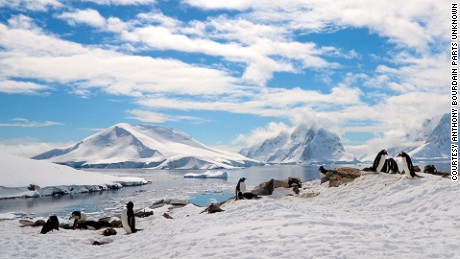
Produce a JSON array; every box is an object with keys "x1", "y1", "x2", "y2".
[{"x1": 32, "y1": 123, "x2": 260, "y2": 169}]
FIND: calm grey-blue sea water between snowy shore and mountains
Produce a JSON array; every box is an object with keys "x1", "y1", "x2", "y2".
[{"x1": 0, "y1": 166, "x2": 319, "y2": 217}]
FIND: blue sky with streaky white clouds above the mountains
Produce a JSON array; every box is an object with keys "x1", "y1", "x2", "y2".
[{"x1": 0, "y1": 0, "x2": 451, "y2": 157}]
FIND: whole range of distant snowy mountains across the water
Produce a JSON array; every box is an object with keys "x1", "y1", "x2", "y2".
[{"x1": 32, "y1": 114, "x2": 450, "y2": 169}]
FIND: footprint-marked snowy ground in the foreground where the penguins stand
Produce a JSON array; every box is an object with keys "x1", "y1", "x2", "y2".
[{"x1": 0, "y1": 174, "x2": 460, "y2": 258}]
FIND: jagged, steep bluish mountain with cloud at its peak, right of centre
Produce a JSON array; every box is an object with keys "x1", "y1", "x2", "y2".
[{"x1": 240, "y1": 126, "x2": 355, "y2": 163}]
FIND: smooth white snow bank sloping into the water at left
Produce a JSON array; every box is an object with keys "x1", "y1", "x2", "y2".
[{"x1": 0, "y1": 153, "x2": 147, "y2": 198}]
